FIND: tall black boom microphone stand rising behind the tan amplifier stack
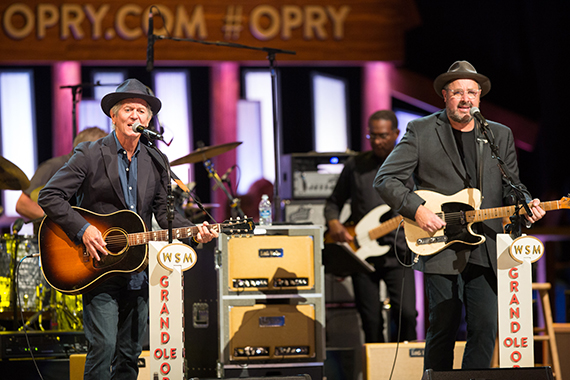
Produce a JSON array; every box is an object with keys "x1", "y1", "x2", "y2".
[{"x1": 152, "y1": 33, "x2": 297, "y2": 221}]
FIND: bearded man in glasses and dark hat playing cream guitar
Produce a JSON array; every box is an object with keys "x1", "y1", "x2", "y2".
[{"x1": 374, "y1": 61, "x2": 545, "y2": 371}]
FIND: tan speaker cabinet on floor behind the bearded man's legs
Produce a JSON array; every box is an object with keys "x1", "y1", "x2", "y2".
[{"x1": 364, "y1": 342, "x2": 465, "y2": 380}]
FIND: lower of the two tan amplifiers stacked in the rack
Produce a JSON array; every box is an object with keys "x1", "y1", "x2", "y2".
[{"x1": 228, "y1": 304, "x2": 315, "y2": 362}]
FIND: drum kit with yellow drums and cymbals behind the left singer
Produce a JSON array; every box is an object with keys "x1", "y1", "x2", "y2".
[{"x1": 0, "y1": 142, "x2": 241, "y2": 330}]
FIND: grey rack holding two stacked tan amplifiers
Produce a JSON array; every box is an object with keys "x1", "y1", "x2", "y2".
[{"x1": 217, "y1": 225, "x2": 325, "y2": 377}]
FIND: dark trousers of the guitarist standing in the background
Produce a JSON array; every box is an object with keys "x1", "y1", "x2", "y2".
[{"x1": 352, "y1": 256, "x2": 418, "y2": 343}]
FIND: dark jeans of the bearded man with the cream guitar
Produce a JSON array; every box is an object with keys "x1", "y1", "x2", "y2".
[{"x1": 424, "y1": 264, "x2": 498, "y2": 371}]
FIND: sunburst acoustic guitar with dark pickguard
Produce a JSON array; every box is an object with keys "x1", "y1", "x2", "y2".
[{"x1": 38, "y1": 207, "x2": 255, "y2": 294}]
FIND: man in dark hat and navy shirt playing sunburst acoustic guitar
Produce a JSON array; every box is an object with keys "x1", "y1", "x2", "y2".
[{"x1": 39, "y1": 79, "x2": 217, "y2": 380}]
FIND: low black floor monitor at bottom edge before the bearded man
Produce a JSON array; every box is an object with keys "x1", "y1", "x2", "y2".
[{"x1": 422, "y1": 367, "x2": 553, "y2": 380}]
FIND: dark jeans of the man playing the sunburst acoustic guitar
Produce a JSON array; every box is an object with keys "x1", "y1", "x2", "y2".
[{"x1": 83, "y1": 276, "x2": 148, "y2": 380}]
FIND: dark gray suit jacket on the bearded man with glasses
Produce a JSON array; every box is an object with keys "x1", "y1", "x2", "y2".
[{"x1": 374, "y1": 110, "x2": 531, "y2": 274}]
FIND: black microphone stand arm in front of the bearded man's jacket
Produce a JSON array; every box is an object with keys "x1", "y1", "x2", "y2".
[{"x1": 477, "y1": 121, "x2": 532, "y2": 238}]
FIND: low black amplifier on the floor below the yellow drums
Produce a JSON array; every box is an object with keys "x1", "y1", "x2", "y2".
[{"x1": 0, "y1": 331, "x2": 87, "y2": 360}]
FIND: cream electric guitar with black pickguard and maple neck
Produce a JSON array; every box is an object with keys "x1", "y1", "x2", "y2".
[{"x1": 404, "y1": 189, "x2": 570, "y2": 256}]
